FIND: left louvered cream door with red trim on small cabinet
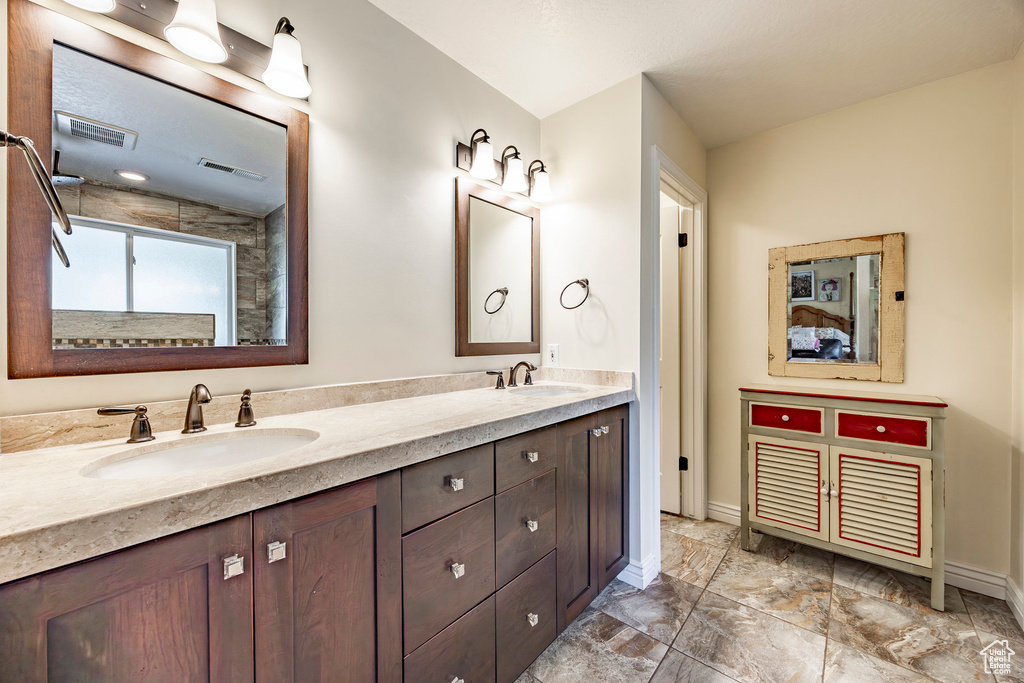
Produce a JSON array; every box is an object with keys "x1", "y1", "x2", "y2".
[{"x1": 746, "y1": 435, "x2": 828, "y2": 541}]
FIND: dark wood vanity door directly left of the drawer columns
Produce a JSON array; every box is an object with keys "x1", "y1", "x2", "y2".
[{"x1": 253, "y1": 472, "x2": 401, "y2": 683}]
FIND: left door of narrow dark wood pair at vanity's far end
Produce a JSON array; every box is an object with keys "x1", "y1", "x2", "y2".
[{"x1": 556, "y1": 415, "x2": 599, "y2": 632}]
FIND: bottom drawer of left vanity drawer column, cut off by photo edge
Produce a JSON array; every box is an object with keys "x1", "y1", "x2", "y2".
[{"x1": 404, "y1": 597, "x2": 495, "y2": 683}]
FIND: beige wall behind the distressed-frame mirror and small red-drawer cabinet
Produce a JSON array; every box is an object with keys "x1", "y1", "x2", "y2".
[{"x1": 708, "y1": 62, "x2": 1020, "y2": 572}]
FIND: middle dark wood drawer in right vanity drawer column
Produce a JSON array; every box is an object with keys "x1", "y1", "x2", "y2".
[{"x1": 495, "y1": 470, "x2": 555, "y2": 587}]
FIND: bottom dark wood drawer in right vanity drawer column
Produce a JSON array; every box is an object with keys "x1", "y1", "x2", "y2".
[{"x1": 493, "y1": 551, "x2": 557, "y2": 683}]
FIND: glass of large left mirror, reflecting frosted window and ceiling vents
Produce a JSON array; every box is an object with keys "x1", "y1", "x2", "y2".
[{"x1": 52, "y1": 45, "x2": 288, "y2": 348}]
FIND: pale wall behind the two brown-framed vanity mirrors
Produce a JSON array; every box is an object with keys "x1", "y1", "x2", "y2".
[{"x1": 0, "y1": 0, "x2": 544, "y2": 415}]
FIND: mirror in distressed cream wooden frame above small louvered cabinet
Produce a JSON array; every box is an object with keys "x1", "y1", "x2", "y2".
[{"x1": 768, "y1": 232, "x2": 905, "y2": 382}]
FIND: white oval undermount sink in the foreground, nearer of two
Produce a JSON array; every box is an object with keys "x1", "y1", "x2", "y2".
[{"x1": 82, "y1": 429, "x2": 319, "y2": 479}]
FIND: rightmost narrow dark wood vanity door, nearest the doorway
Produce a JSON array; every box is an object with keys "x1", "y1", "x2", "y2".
[{"x1": 591, "y1": 405, "x2": 630, "y2": 591}]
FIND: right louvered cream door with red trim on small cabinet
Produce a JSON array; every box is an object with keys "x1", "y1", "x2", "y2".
[{"x1": 829, "y1": 445, "x2": 932, "y2": 567}]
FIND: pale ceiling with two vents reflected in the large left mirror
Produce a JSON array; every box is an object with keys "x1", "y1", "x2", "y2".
[{"x1": 53, "y1": 45, "x2": 288, "y2": 216}]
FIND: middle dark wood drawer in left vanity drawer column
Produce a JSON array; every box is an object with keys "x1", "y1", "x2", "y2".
[{"x1": 401, "y1": 498, "x2": 495, "y2": 654}]
